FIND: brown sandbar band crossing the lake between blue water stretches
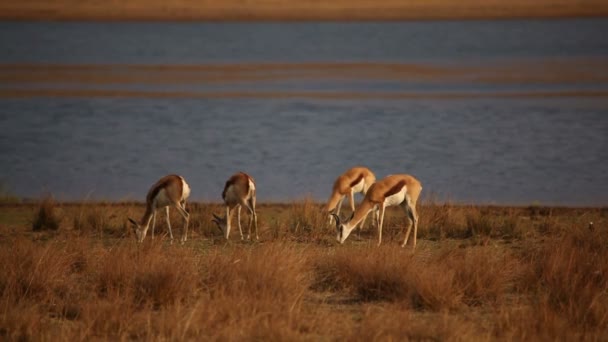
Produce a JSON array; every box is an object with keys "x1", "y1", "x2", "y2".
[{"x1": 0, "y1": 57, "x2": 608, "y2": 100}]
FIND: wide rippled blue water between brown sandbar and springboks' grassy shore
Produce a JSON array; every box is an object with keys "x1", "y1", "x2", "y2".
[{"x1": 0, "y1": 99, "x2": 608, "y2": 205}]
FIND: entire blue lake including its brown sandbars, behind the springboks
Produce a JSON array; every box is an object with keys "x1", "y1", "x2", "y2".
[{"x1": 0, "y1": 19, "x2": 608, "y2": 206}]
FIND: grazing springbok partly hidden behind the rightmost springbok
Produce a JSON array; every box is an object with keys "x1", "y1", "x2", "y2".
[{"x1": 325, "y1": 166, "x2": 376, "y2": 224}]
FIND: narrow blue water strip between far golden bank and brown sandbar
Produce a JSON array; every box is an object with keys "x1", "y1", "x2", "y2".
[{"x1": 0, "y1": 19, "x2": 608, "y2": 64}]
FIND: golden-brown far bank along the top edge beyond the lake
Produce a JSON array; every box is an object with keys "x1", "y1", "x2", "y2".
[{"x1": 0, "y1": 0, "x2": 608, "y2": 21}]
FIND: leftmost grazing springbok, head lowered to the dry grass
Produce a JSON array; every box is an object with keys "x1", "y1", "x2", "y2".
[{"x1": 129, "y1": 175, "x2": 190, "y2": 243}]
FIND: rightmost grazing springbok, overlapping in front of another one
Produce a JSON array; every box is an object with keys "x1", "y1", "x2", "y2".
[{"x1": 331, "y1": 175, "x2": 422, "y2": 248}]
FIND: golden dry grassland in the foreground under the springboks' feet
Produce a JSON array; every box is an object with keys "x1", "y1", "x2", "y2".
[{"x1": 0, "y1": 199, "x2": 608, "y2": 341}]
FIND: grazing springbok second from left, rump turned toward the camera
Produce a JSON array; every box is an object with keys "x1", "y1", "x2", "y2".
[{"x1": 212, "y1": 172, "x2": 260, "y2": 240}]
